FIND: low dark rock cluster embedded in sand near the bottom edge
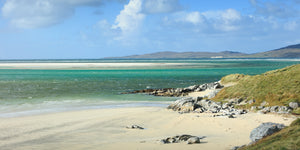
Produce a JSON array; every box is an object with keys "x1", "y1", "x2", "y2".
[{"x1": 160, "y1": 134, "x2": 205, "y2": 144}]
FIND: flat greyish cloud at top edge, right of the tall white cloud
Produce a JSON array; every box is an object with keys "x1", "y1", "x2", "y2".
[{"x1": 142, "y1": 0, "x2": 181, "y2": 14}]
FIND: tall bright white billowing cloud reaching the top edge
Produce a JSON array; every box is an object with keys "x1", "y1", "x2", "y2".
[{"x1": 112, "y1": 0, "x2": 145, "y2": 34}]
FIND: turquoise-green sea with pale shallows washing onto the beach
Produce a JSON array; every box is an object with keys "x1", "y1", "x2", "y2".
[{"x1": 0, "y1": 59, "x2": 300, "y2": 117}]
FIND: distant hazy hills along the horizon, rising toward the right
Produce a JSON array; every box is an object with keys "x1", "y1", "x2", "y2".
[{"x1": 106, "y1": 44, "x2": 300, "y2": 59}]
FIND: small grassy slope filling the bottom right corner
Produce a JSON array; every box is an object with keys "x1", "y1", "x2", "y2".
[{"x1": 239, "y1": 118, "x2": 300, "y2": 150}]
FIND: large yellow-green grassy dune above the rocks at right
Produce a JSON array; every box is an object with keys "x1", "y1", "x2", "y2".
[{"x1": 213, "y1": 64, "x2": 300, "y2": 106}]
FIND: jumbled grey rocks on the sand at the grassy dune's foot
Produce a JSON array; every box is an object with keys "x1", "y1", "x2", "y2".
[{"x1": 167, "y1": 97, "x2": 247, "y2": 118}]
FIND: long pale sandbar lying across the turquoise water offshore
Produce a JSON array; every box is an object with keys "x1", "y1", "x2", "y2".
[{"x1": 0, "y1": 62, "x2": 193, "y2": 69}]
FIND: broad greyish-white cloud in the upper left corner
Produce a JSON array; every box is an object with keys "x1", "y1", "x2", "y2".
[{"x1": 1, "y1": 0, "x2": 104, "y2": 28}]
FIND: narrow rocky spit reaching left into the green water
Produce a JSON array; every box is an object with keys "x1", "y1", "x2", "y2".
[{"x1": 122, "y1": 82, "x2": 223, "y2": 97}]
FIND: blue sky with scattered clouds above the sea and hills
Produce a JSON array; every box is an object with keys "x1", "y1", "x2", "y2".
[{"x1": 0, "y1": 0, "x2": 300, "y2": 59}]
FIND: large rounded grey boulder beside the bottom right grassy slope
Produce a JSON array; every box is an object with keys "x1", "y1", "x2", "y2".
[{"x1": 250, "y1": 122, "x2": 285, "y2": 142}]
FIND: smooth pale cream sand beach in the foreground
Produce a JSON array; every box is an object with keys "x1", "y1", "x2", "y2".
[{"x1": 0, "y1": 107, "x2": 294, "y2": 150}]
